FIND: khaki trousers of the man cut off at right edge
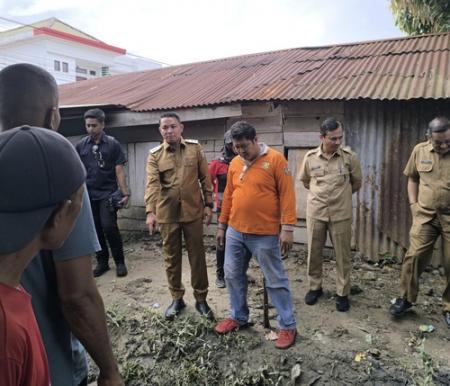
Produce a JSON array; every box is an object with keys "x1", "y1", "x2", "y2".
[{"x1": 400, "y1": 217, "x2": 450, "y2": 311}]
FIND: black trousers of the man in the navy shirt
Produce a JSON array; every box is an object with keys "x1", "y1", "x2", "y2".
[{"x1": 91, "y1": 199, "x2": 125, "y2": 266}]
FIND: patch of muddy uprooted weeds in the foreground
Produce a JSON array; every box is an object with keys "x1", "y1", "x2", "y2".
[{"x1": 90, "y1": 306, "x2": 300, "y2": 386}]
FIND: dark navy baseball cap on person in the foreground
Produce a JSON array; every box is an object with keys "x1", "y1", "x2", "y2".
[{"x1": 0, "y1": 126, "x2": 86, "y2": 255}]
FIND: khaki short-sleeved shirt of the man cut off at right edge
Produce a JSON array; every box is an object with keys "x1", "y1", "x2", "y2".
[{"x1": 403, "y1": 141, "x2": 450, "y2": 224}]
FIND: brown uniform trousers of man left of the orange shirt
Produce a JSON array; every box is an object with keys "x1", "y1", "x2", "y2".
[{"x1": 159, "y1": 218, "x2": 208, "y2": 302}]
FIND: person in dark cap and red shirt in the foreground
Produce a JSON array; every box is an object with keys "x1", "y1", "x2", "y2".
[{"x1": 0, "y1": 126, "x2": 86, "y2": 386}]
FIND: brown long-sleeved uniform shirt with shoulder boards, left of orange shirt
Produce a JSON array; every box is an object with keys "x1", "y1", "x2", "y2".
[{"x1": 144, "y1": 138, "x2": 213, "y2": 223}]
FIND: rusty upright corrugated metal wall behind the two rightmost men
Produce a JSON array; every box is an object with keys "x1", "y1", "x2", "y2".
[{"x1": 344, "y1": 100, "x2": 450, "y2": 261}]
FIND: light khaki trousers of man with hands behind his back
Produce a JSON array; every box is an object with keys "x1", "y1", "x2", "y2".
[{"x1": 306, "y1": 217, "x2": 352, "y2": 296}]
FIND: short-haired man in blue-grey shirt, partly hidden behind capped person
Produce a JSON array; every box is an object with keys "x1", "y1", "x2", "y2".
[{"x1": 0, "y1": 63, "x2": 123, "y2": 386}]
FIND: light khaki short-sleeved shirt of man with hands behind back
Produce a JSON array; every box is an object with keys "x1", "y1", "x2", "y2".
[{"x1": 299, "y1": 146, "x2": 362, "y2": 221}]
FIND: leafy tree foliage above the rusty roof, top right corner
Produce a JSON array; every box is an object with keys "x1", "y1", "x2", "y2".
[{"x1": 391, "y1": 0, "x2": 450, "y2": 35}]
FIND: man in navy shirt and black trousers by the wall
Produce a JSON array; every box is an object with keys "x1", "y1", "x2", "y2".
[{"x1": 76, "y1": 109, "x2": 130, "y2": 277}]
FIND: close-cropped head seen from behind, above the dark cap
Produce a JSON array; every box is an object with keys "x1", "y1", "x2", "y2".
[{"x1": 0, "y1": 63, "x2": 60, "y2": 131}]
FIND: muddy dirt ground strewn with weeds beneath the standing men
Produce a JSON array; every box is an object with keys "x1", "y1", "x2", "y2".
[{"x1": 91, "y1": 233, "x2": 450, "y2": 385}]
